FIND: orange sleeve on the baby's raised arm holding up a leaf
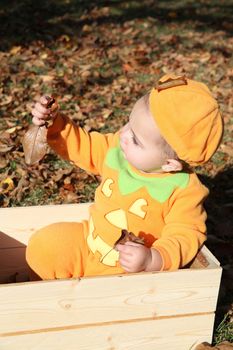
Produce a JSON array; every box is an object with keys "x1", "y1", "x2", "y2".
[{"x1": 47, "y1": 115, "x2": 116, "y2": 175}]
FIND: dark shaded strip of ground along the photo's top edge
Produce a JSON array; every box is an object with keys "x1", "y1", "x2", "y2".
[{"x1": 0, "y1": 0, "x2": 233, "y2": 50}]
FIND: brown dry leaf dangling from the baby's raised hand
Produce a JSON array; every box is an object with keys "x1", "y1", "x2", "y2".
[{"x1": 22, "y1": 125, "x2": 48, "y2": 165}]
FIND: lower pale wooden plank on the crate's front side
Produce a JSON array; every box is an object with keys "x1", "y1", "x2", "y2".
[{"x1": 0, "y1": 310, "x2": 214, "y2": 350}]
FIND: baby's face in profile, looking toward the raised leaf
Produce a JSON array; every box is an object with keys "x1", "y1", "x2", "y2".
[{"x1": 120, "y1": 97, "x2": 166, "y2": 172}]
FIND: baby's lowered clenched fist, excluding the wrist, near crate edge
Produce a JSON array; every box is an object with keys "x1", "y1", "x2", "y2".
[{"x1": 116, "y1": 241, "x2": 152, "y2": 272}]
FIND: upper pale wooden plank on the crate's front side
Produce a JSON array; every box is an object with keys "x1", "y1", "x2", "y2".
[{"x1": 0, "y1": 268, "x2": 221, "y2": 333}]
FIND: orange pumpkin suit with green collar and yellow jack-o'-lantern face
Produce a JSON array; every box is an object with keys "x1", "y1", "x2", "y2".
[{"x1": 27, "y1": 74, "x2": 222, "y2": 279}]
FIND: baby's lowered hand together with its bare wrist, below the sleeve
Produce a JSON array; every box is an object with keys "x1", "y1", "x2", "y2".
[{"x1": 116, "y1": 242, "x2": 162, "y2": 272}]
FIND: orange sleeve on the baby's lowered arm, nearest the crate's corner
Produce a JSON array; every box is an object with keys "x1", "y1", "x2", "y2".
[{"x1": 153, "y1": 174, "x2": 209, "y2": 270}]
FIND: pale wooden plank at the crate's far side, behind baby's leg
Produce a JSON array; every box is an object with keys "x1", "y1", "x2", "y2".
[{"x1": 0, "y1": 203, "x2": 90, "y2": 245}]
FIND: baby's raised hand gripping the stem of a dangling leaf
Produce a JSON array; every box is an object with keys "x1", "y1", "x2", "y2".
[{"x1": 32, "y1": 96, "x2": 58, "y2": 126}]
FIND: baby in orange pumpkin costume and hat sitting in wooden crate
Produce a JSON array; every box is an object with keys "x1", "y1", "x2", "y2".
[{"x1": 26, "y1": 75, "x2": 223, "y2": 279}]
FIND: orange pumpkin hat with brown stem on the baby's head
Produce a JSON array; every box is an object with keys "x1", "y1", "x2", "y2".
[{"x1": 149, "y1": 74, "x2": 223, "y2": 166}]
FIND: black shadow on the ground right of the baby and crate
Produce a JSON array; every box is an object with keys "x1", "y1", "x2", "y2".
[{"x1": 199, "y1": 167, "x2": 233, "y2": 326}]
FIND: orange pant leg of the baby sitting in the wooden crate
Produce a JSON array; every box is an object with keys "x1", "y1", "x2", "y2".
[{"x1": 26, "y1": 222, "x2": 88, "y2": 279}]
